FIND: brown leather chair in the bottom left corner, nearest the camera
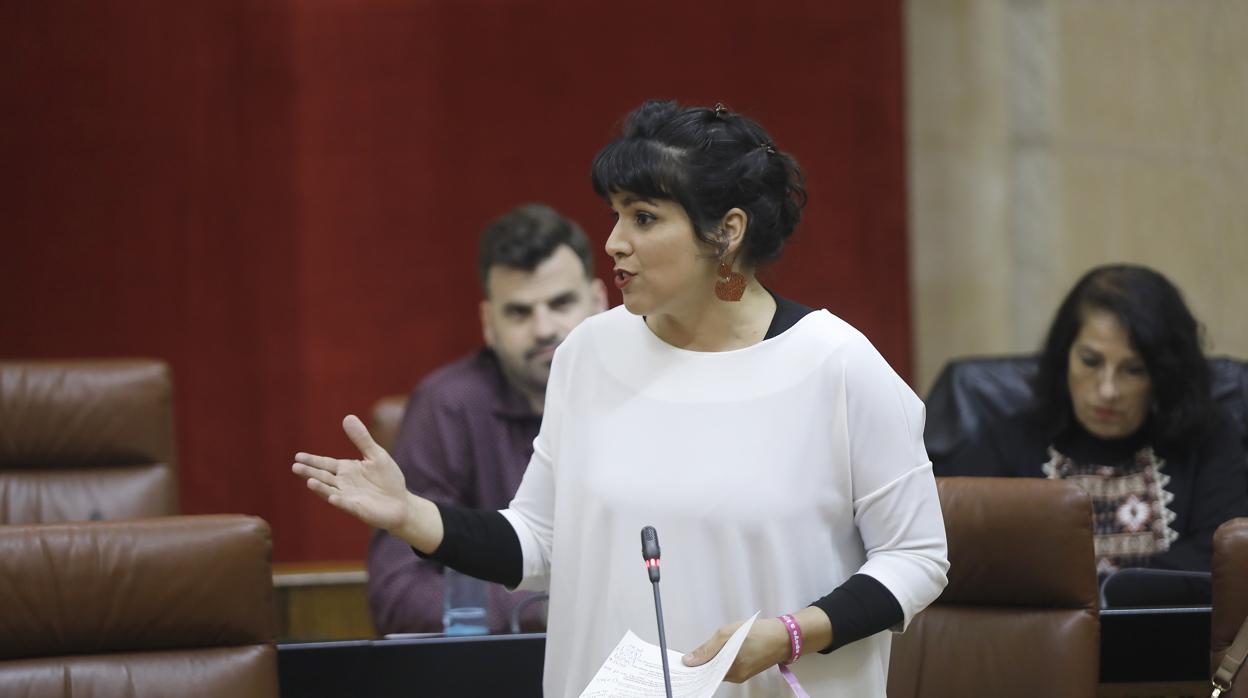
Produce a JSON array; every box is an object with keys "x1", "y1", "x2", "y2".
[{"x1": 0, "y1": 516, "x2": 278, "y2": 698}]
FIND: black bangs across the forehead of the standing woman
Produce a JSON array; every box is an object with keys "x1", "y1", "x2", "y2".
[{"x1": 590, "y1": 139, "x2": 685, "y2": 201}]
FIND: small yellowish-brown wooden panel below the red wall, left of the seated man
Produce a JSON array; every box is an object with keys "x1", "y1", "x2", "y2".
[{"x1": 273, "y1": 562, "x2": 377, "y2": 642}]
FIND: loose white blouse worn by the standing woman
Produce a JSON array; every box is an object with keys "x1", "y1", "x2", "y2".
[{"x1": 503, "y1": 307, "x2": 948, "y2": 698}]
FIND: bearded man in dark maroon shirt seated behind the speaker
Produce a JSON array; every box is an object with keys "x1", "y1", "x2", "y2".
[{"x1": 368, "y1": 204, "x2": 607, "y2": 633}]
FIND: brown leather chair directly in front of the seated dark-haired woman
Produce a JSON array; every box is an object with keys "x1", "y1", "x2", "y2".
[{"x1": 889, "y1": 477, "x2": 1101, "y2": 698}]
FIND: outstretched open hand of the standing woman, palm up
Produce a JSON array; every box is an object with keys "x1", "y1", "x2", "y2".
[{"x1": 291, "y1": 415, "x2": 442, "y2": 552}]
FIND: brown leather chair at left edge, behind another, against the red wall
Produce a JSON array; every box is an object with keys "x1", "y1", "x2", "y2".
[{"x1": 0, "y1": 360, "x2": 178, "y2": 523}]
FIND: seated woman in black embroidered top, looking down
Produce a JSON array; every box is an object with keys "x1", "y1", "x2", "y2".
[{"x1": 936, "y1": 265, "x2": 1248, "y2": 604}]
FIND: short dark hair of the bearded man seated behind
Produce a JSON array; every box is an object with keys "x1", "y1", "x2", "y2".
[{"x1": 477, "y1": 204, "x2": 594, "y2": 298}]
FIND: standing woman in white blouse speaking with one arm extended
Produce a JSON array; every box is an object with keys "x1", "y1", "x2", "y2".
[{"x1": 293, "y1": 101, "x2": 948, "y2": 698}]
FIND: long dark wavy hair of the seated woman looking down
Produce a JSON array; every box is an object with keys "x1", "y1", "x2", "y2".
[{"x1": 1035, "y1": 265, "x2": 1213, "y2": 455}]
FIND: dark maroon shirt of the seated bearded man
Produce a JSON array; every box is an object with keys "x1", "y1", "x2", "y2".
[{"x1": 368, "y1": 350, "x2": 545, "y2": 633}]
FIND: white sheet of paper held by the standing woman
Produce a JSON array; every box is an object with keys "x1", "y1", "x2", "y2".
[{"x1": 580, "y1": 613, "x2": 759, "y2": 698}]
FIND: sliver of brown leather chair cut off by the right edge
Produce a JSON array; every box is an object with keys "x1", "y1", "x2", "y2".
[{"x1": 1209, "y1": 518, "x2": 1248, "y2": 698}]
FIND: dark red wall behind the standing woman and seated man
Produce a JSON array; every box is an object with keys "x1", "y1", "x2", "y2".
[{"x1": 0, "y1": 0, "x2": 911, "y2": 559}]
